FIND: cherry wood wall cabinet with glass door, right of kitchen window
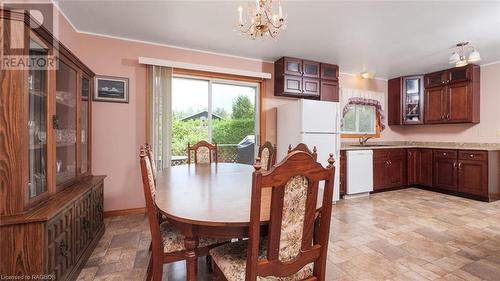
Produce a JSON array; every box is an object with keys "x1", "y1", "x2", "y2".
[{"x1": 387, "y1": 65, "x2": 480, "y2": 125}]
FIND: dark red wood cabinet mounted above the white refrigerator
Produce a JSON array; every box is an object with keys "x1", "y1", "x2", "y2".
[{"x1": 274, "y1": 57, "x2": 339, "y2": 102}]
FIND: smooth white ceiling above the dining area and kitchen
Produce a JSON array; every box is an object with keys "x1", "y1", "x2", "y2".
[{"x1": 58, "y1": 0, "x2": 500, "y2": 78}]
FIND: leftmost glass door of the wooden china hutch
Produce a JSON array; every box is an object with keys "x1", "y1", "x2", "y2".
[{"x1": 27, "y1": 37, "x2": 49, "y2": 199}]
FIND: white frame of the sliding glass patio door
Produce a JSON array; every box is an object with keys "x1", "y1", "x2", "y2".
[{"x1": 172, "y1": 72, "x2": 260, "y2": 153}]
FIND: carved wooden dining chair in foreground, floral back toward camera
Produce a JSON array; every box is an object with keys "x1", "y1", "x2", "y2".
[{"x1": 210, "y1": 151, "x2": 335, "y2": 281}]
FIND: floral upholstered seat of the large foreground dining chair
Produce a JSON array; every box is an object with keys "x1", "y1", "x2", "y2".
[{"x1": 210, "y1": 240, "x2": 313, "y2": 281}]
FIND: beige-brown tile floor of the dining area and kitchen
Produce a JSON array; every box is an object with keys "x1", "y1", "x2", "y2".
[{"x1": 78, "y1": 188, "x2": 500, "y2": 281}]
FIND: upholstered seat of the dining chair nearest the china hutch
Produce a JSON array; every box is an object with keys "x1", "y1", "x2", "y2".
[{"x1": 160, "y1": 221, "x2": 230, "y2": 253}]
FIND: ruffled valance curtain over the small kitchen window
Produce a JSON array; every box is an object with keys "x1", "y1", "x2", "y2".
[{"x1": 340, "y1": 88, "x2": 385, "y2": 131}]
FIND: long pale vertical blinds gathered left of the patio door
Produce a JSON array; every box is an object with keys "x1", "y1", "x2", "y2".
[{"x1": 147, "y1": 65, "x2": 172, "y2": 169}]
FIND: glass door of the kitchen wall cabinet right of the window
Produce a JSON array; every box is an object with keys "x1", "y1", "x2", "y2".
[{"x1": 403, "y1": 76, "x2": 424, "y2": 124}]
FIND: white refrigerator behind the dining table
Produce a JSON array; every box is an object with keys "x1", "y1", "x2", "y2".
[{"x1": 276, "y1": 99, "x2": 340, "y2": 201}]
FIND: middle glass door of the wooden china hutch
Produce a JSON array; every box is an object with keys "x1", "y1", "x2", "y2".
[{"x1": 53, "y1": 59, "x2": 78, "y2": 185}]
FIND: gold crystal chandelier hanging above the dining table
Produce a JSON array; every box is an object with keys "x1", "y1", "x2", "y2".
[{"x1": 236, "y1": 0, "x2": 286, "y2": 40}]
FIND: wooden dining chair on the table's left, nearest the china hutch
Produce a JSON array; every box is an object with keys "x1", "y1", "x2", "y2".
[{"x1": 140, "y1": 145, "x2": 229, "y2": 281}]
